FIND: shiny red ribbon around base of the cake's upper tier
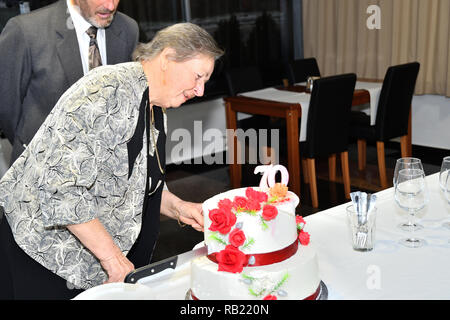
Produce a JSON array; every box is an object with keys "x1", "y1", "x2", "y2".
[{"x1": 207, "y1": 239, "x2": 298, "y2": 267}]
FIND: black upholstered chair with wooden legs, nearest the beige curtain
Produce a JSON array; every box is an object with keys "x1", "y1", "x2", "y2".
[{"x1": 350, "y1": 62, "x2": 420, "y2": 189}]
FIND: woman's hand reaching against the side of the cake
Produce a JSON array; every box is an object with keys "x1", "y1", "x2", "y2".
[{"x1": 161, "y1": 190, "x2": 203, "y2": 231}]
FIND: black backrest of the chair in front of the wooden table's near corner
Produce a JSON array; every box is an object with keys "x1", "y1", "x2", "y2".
[{"x1": 301, "y1": 73, "x2": 356, "y2": 158}]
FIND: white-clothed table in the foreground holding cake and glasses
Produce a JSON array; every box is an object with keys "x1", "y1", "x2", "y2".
[{"x1": 76, "y1": 174, "x2": 450, "y2": 300}]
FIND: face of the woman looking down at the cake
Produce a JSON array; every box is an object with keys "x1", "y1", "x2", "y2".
[{"x1": 160, "y1": 54, "x2": 214, "y2": 108}]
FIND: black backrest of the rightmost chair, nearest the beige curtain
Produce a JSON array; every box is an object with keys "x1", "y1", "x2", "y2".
[{"x1": 375, "y1": 62, "x2": 420, "y2": 141}]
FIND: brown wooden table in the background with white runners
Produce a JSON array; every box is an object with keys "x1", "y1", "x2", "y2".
[{"x1": 224, "y1": 79, "x2": 412, "y2": 195}]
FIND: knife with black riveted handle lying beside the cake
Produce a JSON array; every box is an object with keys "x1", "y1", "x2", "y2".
[{"x1": 124, "y1": 245, "x2": 208, "y2": 283}]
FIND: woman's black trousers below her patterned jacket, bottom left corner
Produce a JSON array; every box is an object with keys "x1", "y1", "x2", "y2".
[{"x1": 0, "y1": 212, "x2": 83, "y2": 300}]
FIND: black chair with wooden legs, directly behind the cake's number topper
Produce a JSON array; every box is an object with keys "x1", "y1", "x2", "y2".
[{"x1": 300, "y1": 73, "x2": 356, "y2": 208}]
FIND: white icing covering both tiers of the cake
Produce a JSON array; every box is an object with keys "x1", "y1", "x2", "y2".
[{"x1": 191, "y1": 185, "x2": 320, "y2": 300}]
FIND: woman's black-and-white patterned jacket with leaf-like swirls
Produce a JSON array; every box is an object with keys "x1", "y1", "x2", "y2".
[{"x1": 0, "y1": 62, "x2": 167, "y2": 289}]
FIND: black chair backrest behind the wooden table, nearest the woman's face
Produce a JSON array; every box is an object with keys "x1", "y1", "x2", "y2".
[{"x1": 225, "y1": 66, "x2": 264, "y2": 96}]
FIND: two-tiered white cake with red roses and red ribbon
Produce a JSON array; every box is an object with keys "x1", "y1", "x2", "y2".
[{"x1": 191, "y1": 165, "x2": 320, "y2": 300}]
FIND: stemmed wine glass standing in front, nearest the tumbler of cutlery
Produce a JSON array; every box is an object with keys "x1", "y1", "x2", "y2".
[{"x1": 395, "y1": 169, "x2": 428, "y2": 248}]
